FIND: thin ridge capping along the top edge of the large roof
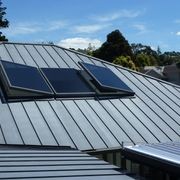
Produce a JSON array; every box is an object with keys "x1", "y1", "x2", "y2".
[{"x1": 0, "y1": 42, "x2": 180, "y2": 88}]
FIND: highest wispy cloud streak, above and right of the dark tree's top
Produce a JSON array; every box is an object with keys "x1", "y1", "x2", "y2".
[{"x1": 93, "y1": 9, "x2": 140, "y2": 22}]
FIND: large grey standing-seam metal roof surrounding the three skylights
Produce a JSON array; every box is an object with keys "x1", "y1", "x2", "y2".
[{"x1": 0, "y1": 43, "x2": 180, "y2": 150}]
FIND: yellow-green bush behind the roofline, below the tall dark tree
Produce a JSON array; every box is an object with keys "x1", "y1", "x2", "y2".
[{"x1": 113, "y1": 56, "x2": 137, "y2": 70}]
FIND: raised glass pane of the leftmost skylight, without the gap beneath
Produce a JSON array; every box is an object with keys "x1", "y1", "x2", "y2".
[{"x1": 1, "y1": 61, "x2": 52, "y2": 94}]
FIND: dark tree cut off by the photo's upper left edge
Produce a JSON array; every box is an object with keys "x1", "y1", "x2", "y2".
[{"x1": 0, "y1": 0, "x2": 9, "y2": 41}]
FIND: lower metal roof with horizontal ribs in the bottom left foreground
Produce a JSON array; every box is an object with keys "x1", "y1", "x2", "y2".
[{"x1": 0, "y1": 146, "x2": 132, "y2": 180}]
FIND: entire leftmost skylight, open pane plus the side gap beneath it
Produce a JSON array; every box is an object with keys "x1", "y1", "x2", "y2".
[{"x1": 1, "y1": 61, "x2": 53, "y2": 98}]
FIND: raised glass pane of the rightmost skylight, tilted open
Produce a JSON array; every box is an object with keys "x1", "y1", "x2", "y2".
[{"x1": 80, "y1": 62, "x2": 134, "y2": 94}]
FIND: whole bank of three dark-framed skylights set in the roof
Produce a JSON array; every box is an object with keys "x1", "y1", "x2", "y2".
[{"x1": 0, "y1": 60, "x2": 135, "y2": 101}]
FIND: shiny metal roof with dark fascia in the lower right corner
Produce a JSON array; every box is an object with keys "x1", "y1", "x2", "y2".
[{"x1": 123, "y1": 142, "x2": 180, "y2": 174}]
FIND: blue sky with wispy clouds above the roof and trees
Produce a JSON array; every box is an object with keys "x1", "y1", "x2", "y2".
[{"x1": 2, "y1": 0, "x2": 180, "y2": 51}]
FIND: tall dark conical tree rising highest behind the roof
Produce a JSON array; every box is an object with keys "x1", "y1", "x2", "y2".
[{"x1": 93, "y1": 30, "x2": 133, "y2": 62}]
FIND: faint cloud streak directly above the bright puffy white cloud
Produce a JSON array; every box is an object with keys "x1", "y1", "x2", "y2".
[{"x1": 74, "y1": 24, "x2": 110, "y2": 33}]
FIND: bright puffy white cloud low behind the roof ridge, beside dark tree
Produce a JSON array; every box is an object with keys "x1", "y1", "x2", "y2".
[{"x1": 57, "y1": 37, "x2": 102, "y2": 49}]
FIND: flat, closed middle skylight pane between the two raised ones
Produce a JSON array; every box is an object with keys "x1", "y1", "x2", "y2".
[{"x1": 41, "y1": 68, "x2": 95, "y2": 96}]
